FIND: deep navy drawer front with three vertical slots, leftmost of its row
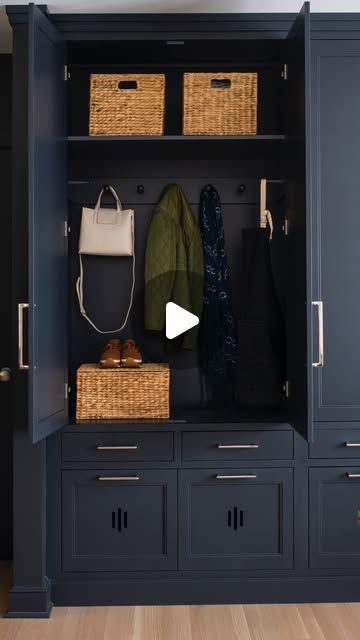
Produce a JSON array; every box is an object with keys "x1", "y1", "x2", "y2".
[{"x1": 62, "y1": 469, "x2": 177, "y2": 571}]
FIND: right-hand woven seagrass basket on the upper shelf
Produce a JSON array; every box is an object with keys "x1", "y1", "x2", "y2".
[{"x1": 183, "y1": 73, "x2": 258, "y2": 136}]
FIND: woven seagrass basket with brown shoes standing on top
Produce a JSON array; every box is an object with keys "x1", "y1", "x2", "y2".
[{"x1": 76, "y1": 363, "x2": 170, "y2": 420}]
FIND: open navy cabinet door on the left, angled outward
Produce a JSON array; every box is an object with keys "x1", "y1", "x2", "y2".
[{"x1": 28, "y1": 5, "x2": 68, "y2": 442}]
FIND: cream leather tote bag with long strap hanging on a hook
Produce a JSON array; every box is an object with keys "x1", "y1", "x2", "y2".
[{"x1": 76, "y1": 187, "x2": 135, "y2": 333}]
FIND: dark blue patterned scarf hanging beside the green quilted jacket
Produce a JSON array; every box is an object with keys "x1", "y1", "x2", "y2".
[{"x1": 199, "y1": 185, "x2": 237, "y2": 404}]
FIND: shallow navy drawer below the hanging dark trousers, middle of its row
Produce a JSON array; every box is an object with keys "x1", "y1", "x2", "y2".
[{"x1": 182, "y1": 431, "x2": 294, "y2": 461}]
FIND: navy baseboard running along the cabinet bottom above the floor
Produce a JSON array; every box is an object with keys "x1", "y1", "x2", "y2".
[{"x1": 52, "y1": 576, "x2": 360, "y2": 606}]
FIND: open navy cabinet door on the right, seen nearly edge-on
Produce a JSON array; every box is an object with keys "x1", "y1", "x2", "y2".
[{"x1": 285, "y1": 2, "x2": 313, "y2": 441}]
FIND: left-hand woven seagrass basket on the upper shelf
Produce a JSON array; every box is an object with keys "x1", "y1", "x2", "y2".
[{"x1": 89, "y1": 73, "x2": 165, "y2": 136}]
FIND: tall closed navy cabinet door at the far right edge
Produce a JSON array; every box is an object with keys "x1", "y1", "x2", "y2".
[{"x1": 312, "y1": 40, "x2": 360, "y2": 421}]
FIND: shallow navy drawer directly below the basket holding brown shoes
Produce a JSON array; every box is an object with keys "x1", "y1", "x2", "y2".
[{"x1": 62, "y1": 432, "x2": 174, "y2": 462}]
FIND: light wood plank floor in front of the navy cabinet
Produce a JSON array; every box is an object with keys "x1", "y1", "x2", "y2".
[{"x1": 0, "y1": 563, "x2": 360, "y2": 640}]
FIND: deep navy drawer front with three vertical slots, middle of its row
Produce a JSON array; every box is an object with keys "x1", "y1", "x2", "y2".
[{"x1": 179, "y1": 467, "x2": 293, "y2": 570}]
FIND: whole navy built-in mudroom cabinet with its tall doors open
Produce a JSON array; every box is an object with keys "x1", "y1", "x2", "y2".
[{"x1": 7, "y1": 3, "x2": 360, "y2": 617}]
